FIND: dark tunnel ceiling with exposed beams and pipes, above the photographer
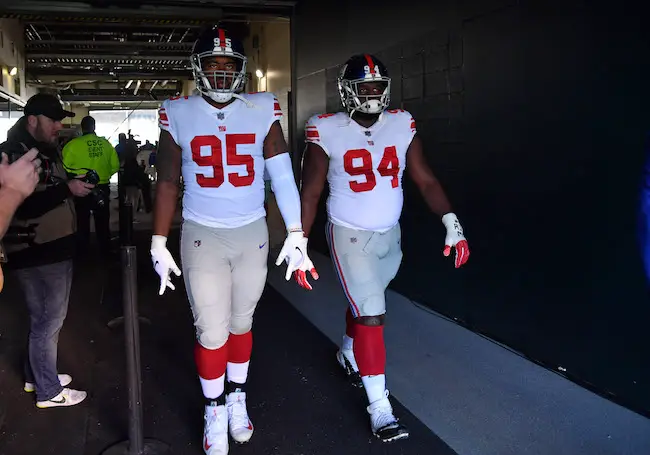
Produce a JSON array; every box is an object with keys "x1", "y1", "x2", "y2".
[{"x1": 0, "y1": 0, "x2": 294, "y2": 103}]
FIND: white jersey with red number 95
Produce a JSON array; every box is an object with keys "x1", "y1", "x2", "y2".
[{"x1": 159, "y1": 93, "x2": 282, "y2": 228}]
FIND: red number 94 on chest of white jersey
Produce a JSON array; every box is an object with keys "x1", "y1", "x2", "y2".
[{"x1": 343, "y1": 146, "x2": 399, "y2": 193}]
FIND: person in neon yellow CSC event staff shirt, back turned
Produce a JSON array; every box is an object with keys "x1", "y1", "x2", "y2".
[{"x1": 63, "y1": 116, "x2": 120, "y2": 257}]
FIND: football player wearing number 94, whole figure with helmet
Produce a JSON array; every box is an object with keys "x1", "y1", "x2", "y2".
[{"x1": 295, "y1": 54, "x2": 469, "y2": 442}]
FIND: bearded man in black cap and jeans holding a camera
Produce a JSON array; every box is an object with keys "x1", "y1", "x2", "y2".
[{"x1": 0, "y1": 93, "x2": 94, "y2": 408}]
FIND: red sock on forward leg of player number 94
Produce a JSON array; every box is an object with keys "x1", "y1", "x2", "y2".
[{"x1": 352, "y1": 324, "x2": 386, "y2": 377}]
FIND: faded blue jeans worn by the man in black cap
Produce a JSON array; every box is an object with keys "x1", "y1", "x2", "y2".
[{"x1": 15, "y1": 260, "x2": 72, "y2": 401}]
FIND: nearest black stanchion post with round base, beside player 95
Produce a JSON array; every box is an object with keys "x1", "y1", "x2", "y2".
[{"x1": 103, "y1": 245, "x2": 169, "y2": 455}]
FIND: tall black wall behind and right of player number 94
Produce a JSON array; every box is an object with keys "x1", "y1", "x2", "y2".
[{"x1": 296, "y1": 0, "x2": 650, "y2": 416}]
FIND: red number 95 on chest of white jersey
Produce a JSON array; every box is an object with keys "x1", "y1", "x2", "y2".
[{"x1": 190, "y1": 134, "x2": 255, "y2": 188}]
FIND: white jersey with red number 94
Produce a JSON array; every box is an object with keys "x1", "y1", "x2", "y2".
[{"x1": 305, "y1": 109, "x2": 416, "y2": 232}]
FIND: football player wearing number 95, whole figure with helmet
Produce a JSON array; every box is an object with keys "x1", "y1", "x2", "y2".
[{"x1": 151, "y1": 27, "x2": 316, "y2": 455}]
